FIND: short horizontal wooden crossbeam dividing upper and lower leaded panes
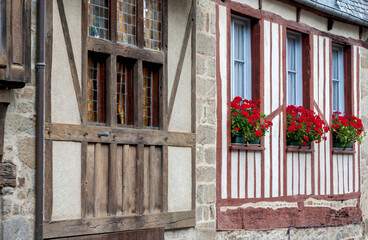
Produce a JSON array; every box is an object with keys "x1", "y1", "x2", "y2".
[{"x1": 87, "y1": 37, "x2": 165, "y2": 64}]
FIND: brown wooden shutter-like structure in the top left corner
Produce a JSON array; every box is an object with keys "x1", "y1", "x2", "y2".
[{"x1": 0, "y1": 0, "x2": 31, "y2": 88}]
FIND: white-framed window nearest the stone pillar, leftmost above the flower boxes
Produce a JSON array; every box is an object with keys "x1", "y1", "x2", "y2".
[{"x1": 231, "y1": 16, "x2": 252, "y2": 99}]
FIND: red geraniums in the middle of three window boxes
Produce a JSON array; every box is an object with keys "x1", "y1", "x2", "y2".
[{"x1": 286, "y1": 105, "x2": 328, "y2": 147}]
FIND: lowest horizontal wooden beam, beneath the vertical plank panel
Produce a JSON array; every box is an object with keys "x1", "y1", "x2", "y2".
[{"x1": 44, "y1": 211, "x2": 195, "y2": 239}]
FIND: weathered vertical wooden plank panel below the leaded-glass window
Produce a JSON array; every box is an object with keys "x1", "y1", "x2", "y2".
[{"x1": 83, "y1": 143, "x2": 163, "y2": 218}]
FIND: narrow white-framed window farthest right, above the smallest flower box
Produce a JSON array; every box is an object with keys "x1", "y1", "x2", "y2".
[{"x1": 332, "y1": 44, "x2": 345, "y2": 112}]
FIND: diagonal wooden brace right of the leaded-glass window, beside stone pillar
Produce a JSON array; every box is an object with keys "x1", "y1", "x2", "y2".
[{"x1": 167, "y1": 5, "x2": 195, "y2": 126}]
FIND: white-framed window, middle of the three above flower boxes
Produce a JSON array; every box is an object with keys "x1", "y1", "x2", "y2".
[{"x1": 286, "y1": 31, "x2": 303, "y2": 106}]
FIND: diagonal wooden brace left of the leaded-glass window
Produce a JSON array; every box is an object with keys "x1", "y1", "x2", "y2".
[{"x1": 57, "y1": 0, "x2": 83, "y2": 121}]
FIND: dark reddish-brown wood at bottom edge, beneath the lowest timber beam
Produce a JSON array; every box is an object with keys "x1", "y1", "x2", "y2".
[{"x1": 54, "y1": 228, "x2": 165, "y2": 240}]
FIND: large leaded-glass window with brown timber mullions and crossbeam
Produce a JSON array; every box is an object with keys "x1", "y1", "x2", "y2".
[{"x1": 86, "y1": 0, "x2": 164, "y2": 128}]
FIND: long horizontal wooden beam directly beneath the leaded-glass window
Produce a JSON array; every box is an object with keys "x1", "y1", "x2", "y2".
[{"x1": 45, "y1": 123, "x2": 195, "y2": 147}]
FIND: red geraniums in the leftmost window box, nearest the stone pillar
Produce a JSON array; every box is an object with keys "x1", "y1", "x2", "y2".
[{"x1": 231, "y1": 97, "x2": 272, "y2": 141}]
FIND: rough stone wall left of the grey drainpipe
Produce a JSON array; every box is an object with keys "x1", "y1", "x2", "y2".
[{"x1": 0, "y1": 0, "x2": 37, "y2": 240}]
